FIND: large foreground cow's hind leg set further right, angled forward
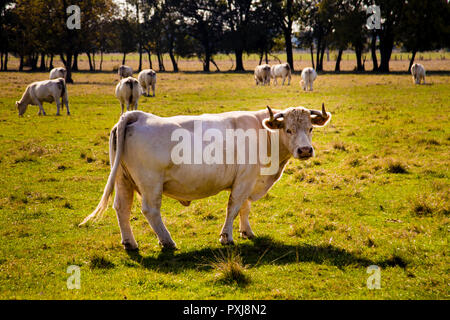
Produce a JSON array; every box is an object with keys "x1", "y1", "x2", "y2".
[{"x1": 142, "y1": 183, "x2": 176, "y2": 248}]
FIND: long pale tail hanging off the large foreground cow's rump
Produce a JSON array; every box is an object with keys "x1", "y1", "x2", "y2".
[{"x1": 78, "y1": 112, "x2": 139, "y2": 227}]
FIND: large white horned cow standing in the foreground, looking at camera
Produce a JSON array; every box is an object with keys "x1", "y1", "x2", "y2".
[{"x1": 80, "y1": 104, "x2": 331, "y2": 249}]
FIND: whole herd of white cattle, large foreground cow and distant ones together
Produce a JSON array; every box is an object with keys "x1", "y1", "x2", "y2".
[{"x1": 10, "y1": 63, "x2": 425, "y2": 250}]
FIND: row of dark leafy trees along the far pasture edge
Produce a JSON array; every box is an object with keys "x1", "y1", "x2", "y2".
[{"x1": 0, "y1": 0, "x2": 450, "y2": 82}]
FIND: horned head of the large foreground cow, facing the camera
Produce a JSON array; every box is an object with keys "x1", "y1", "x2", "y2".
[{"x1": 263, "y1": 103, "x2": 331, "y2": 159}]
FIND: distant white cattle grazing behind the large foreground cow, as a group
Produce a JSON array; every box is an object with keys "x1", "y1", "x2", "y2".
[{"x1": 16, "y1": 63, "x2": 425, "y2": 116}]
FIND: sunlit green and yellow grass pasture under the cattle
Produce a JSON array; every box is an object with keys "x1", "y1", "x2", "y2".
[{"x1": 0, "y1": 66, "x2": 450, "y2": 299}]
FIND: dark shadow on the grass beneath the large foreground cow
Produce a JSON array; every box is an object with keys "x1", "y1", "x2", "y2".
[{"x1": 127, "y1": 236, "x2": 376, "y2": 273}]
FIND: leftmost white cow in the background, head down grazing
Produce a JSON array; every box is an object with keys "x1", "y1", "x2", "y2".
[{"x1": 16, "y1": 78, "x2": 70, "y2": 116}]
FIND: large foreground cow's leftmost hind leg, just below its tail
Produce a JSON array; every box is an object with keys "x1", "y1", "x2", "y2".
[{"x1": 113, "y1": 174, "x2": 138, "y2": 250}]
